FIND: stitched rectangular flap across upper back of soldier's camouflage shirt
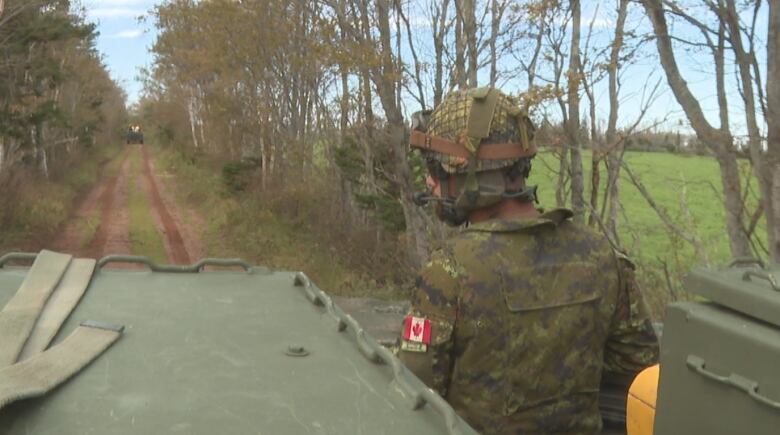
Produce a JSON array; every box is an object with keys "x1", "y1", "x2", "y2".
[{"x1": 501, "y1": 263, "x2": 601, "y2": 313}]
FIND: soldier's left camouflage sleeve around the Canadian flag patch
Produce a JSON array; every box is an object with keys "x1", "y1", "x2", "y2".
[{"x1": 399, "y1": 252, "x2": 459, "y2": 396}]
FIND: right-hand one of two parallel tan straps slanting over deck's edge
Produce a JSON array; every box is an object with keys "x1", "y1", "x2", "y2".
[{"x1": 18, "y1": 258, "x2": 96, "y2": 361}]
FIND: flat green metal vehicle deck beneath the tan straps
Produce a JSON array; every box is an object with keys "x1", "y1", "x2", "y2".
[{"x1": 0, "y1": 255, "x2": 474, "y2": 435}]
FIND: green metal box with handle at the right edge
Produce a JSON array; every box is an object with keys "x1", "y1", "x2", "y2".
[{"x1": 655, "y1": 267, "x2": 780, "y2": 435}]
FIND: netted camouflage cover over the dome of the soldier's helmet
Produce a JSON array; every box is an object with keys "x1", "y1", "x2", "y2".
[{"x1": 412, "y1": 88, "x2": 536, "y2": 174}]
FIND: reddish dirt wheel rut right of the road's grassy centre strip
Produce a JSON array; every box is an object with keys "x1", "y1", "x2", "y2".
[{"x1": 140, "y1": 145, "x2": 190, "y2": 264}]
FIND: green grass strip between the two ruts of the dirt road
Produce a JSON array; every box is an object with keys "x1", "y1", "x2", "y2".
[{"x1": 127, "y1": 152, "x2": 168, "y2": 264}]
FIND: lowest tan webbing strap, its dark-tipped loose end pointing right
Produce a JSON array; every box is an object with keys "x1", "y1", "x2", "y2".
[{"x1": 0, "y1": 323, "x2": 122, "y2": 409}]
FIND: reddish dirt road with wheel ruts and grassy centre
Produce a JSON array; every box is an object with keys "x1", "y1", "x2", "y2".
[{"x1": 50, "y1": 145, "x2": 203, "y2": 264}]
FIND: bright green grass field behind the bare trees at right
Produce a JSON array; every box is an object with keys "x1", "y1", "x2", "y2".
[{"x1": 530, "y1": 152, "x2": 766, "y2": 311}]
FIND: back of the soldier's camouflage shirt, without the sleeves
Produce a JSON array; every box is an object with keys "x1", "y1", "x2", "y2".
[{"x1": 447, "y1": 210, "x2": 619, "y2": 434}]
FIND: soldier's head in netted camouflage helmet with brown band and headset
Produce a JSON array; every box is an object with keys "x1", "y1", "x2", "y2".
[{"x1": 409, "y1": 88, "x2": 536, "y2": 225}]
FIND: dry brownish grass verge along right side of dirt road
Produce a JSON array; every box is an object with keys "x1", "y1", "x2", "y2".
[{"x1": 157, "y1": 151, "x2": 412, "y2": 299}]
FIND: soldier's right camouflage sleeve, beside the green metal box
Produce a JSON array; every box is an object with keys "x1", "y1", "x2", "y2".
[{"x1": 604, "y1": 254, "x2": 658, "y2": 375}]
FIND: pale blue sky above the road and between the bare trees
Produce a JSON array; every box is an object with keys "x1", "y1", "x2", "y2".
[{"x1": 80, "y1": 0, "x2": 766, "y2": 135}]
